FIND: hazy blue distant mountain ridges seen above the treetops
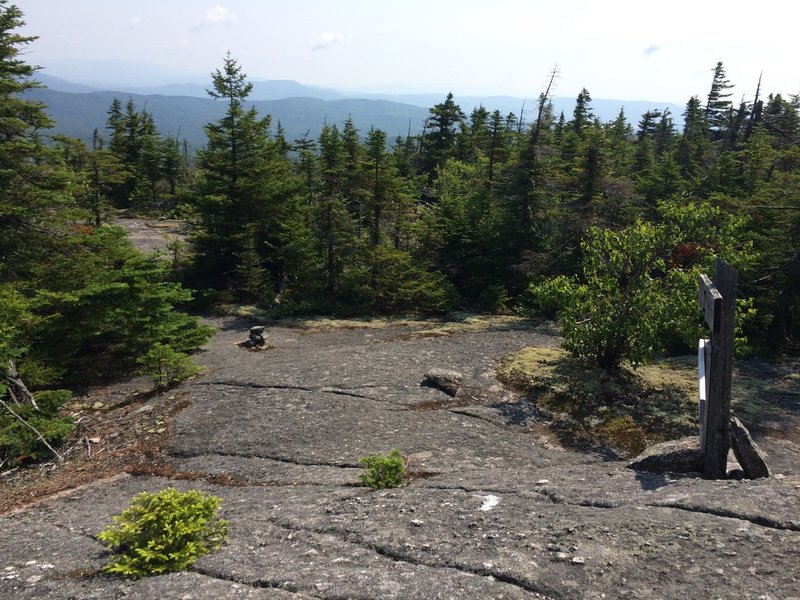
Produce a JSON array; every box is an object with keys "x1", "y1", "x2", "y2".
[{"x1": 27, "y1": 73, "x2": 683, "y2": 148}]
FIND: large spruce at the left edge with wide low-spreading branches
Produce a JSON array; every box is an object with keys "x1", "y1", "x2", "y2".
[{"x1": 0, "y1": 0, "x2": 209, "y2": 388}]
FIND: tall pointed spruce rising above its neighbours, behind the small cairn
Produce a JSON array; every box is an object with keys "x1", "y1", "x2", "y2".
[{"x1": 194, "y1": 54, "x2": 296, "y2": 301}]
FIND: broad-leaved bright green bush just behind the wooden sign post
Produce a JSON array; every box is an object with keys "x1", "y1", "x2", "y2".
[{"x1": 529, "y1": 201, "x2": 752, "y2": 373}]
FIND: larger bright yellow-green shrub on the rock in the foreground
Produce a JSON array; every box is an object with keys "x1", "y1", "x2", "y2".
[{"x1": 97, "y1": 488, "x2": 228, "y2": 579}]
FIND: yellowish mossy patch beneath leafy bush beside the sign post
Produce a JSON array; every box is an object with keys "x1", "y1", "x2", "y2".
[{"x1": 498, "y1": 348, "x2": 697, "y2": 457}]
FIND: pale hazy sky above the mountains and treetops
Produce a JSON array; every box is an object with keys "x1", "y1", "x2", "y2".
[{"x1": 16, "y1": 0, "x2": 800, "y2": 104}]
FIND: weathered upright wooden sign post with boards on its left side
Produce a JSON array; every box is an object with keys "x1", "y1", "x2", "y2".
[{"x1": 698, "y1": 259, "x2": 739, "y2": 479}]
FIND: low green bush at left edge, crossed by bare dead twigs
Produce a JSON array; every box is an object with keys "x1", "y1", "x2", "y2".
[{"x1": 0, "y1": 386, "x2": 75, "y2": 465}]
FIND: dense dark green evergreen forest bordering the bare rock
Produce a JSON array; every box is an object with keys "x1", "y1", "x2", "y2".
[{"x1": 0, "y1": 0, "x2": 800, "y2": 418}]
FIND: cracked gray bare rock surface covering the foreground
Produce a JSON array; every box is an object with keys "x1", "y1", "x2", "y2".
[{"x1": 0, "y1": 321, "x2": 800, "y2": 600}]
